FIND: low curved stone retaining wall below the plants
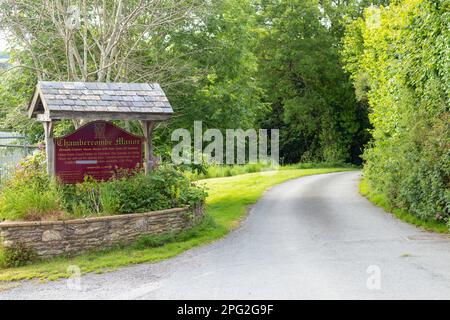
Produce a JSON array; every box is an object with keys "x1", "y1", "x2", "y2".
[{"x1": 0, "y1": 207, "x2": 203, "y2": 258}]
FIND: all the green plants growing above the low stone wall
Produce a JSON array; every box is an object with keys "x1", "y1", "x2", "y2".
[{"x1": 0, "y1": 152, "x2": 206, "y2": 220}]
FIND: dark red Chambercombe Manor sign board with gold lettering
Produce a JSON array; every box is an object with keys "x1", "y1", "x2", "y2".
[{"x1": 54, "y1": 121, "x2": 143, "y2": 183}]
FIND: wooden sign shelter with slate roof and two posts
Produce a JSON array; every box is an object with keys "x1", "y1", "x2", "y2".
[{"x1": 28, "y1": 81, "x2": 173, "y2": 175}]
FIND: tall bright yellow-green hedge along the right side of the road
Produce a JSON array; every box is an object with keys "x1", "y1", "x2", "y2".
[{"x1": 344, "y1": 0, "x2": 450, "y2": 221}]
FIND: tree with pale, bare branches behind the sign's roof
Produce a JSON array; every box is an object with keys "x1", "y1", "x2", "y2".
[{"x1": 0, "y1": 0, "x2": 195, "y2": 82}]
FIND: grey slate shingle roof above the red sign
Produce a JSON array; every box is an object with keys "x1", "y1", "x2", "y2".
[{"x1": 29, "y1": 81, "x2": 173, "y2": 119}]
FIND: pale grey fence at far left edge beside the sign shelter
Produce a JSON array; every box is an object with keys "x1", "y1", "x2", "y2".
[{"x1": 0, "y1": 131, "x2": 38, "y2": 183}]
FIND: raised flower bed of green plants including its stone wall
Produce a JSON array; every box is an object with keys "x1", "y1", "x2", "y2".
[{"x1": 0, "y1": 152, "x2": 206, "y2": 261}]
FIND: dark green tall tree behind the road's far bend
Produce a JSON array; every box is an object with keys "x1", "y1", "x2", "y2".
[{"x1": 257, "y1": 0, "x2": 368, "y2": 162}]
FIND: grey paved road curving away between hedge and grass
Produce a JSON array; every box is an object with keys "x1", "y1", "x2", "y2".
[{"x1": 0, "y1": 172, "x2": 450, "y2": 299}]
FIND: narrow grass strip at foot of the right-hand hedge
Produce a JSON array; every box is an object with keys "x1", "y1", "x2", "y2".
[{"x1": 359, "y1": 179, "x2": 450, "y2": 233}]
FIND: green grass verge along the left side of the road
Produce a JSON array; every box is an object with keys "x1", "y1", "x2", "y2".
[{"x1": 0, "y1": 168, "x2": 349, "y2": 284}]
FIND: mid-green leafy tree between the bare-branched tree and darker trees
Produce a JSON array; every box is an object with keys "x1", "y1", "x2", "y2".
[{"x1": 163, "y1": 0, "x2": 262, "y2": 129}]
